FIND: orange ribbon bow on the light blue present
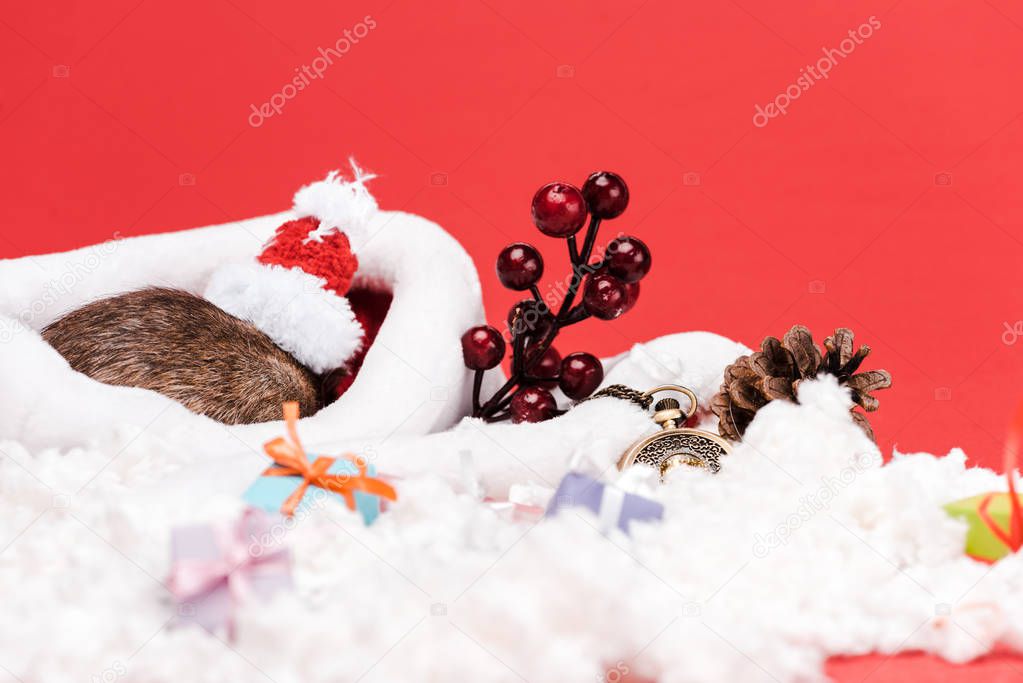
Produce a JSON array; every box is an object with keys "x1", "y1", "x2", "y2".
[{"x1": 263, "y1": 402, "x2": 398, "y2": 516}]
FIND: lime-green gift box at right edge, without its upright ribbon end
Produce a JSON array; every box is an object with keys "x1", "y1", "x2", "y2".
[{"x1": 944, "y1": 493, "x2": 1023, "y2": 562}]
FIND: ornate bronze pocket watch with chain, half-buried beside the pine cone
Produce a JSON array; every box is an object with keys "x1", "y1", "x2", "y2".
[{"x1": 594, "y1": 384, "x2": 731, "y2": 481}]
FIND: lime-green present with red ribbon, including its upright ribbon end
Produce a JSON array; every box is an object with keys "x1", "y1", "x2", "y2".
[{"x1": 944, "y1": 405, "x2": 1023, "y2": 562}]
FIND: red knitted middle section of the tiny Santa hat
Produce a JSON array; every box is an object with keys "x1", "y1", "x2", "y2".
[{"x1": 258, "y1": 217, "x2": 359, "y2": 297}]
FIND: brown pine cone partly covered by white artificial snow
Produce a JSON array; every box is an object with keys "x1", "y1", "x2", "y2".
[{"x1": 711, "y1": 325, "x2": 892, "y2": 441}]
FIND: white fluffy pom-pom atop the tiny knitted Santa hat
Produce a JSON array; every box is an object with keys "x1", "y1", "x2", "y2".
[{"x1": 295, "y1": 158, "x2": 379, "y2": 252}]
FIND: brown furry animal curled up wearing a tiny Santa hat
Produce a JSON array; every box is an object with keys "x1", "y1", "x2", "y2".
[{"x1": 42, "y1": 287, "x2": 321, "y2": 424}]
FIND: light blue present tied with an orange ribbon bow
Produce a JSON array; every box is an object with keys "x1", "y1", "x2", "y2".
[{"x1": 243, "y1": 403, "x2": 398, "y2": 526}]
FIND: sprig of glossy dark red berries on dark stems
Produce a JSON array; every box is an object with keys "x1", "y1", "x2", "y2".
[{"x1": 461, "y1": 171, "x2": 651, "y2": 422}]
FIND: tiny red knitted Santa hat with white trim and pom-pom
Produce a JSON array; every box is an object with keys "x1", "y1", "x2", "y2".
[{"x1": 205, "y1": 160, "x2": 377, "y2": 372}]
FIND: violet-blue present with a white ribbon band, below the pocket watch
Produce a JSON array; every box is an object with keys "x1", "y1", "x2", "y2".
[{"x1": 547, "y1": 472, "x2": 664, "y2": 534}]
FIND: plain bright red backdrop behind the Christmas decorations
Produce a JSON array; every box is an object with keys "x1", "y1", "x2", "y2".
[{"x1": 0, "y1": 0, "x2": 1023, "y2": 678}]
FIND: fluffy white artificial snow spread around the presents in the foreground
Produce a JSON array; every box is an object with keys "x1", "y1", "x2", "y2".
[{"x1": 0, "y1": 333, "x2": 1023, "y2": 683}]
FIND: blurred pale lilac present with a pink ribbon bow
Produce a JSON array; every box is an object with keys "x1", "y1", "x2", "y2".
[{"x1": 167, "y1": 508, "x2": 292, "y2": 639}]
